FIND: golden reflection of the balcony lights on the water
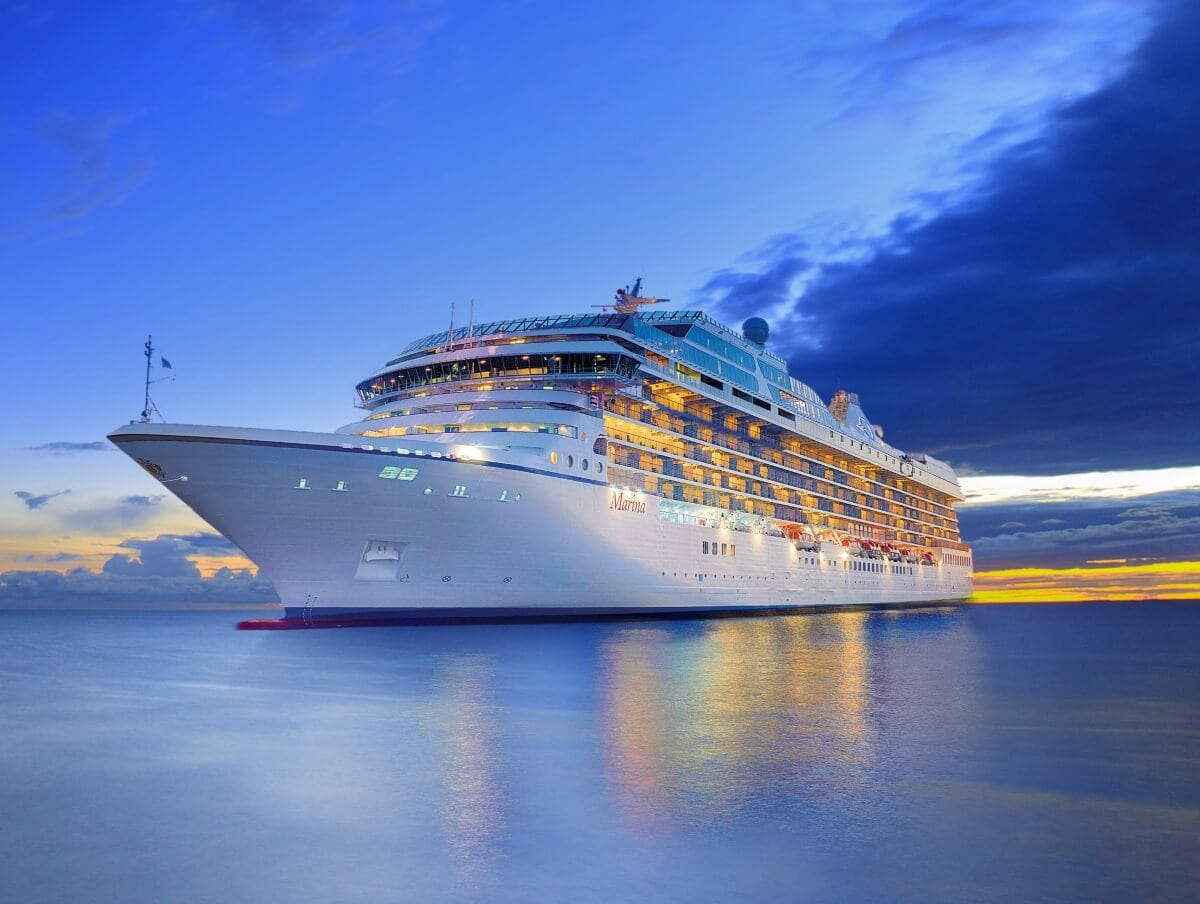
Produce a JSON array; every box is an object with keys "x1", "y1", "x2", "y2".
[{"x1": 601, "y1": 612, "x2": 874, "y2": 833}]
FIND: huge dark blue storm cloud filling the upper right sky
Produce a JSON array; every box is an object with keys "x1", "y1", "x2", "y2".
[{"x1": 700, "y1": 2, "x2": 1200, "y2": 474}]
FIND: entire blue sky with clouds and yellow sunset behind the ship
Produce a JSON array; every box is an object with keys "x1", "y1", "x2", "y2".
[{"x1": 0, "y1": 0, "x2": 1200, "y2": 606}]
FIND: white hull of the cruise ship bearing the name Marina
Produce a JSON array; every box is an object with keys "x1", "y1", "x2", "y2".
[{"x1": 110, "y1": 424, "x2": 971, "y2": 617}]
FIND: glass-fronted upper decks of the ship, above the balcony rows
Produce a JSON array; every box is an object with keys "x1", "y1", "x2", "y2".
[{"x1": 358, "y1": 311, "x2": 962, "y2": 499}]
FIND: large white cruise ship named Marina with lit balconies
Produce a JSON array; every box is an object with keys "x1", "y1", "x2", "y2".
[{"x1": 109, "y1": 286, "x2": 972, "y2": 624}]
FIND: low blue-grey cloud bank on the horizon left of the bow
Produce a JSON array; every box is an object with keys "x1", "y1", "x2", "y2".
[{"x1": 0, "y1": 533, "x2": 278, "y2": 609}]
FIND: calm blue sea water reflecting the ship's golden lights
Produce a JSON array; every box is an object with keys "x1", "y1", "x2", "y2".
[{"x1": 0, "y1": 604, "x2": 1200, "y2": 903}]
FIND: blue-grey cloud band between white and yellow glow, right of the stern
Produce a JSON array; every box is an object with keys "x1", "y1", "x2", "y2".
[{"x1": 959, "y1": 491, "x2": 1200, "y2": 571}]
